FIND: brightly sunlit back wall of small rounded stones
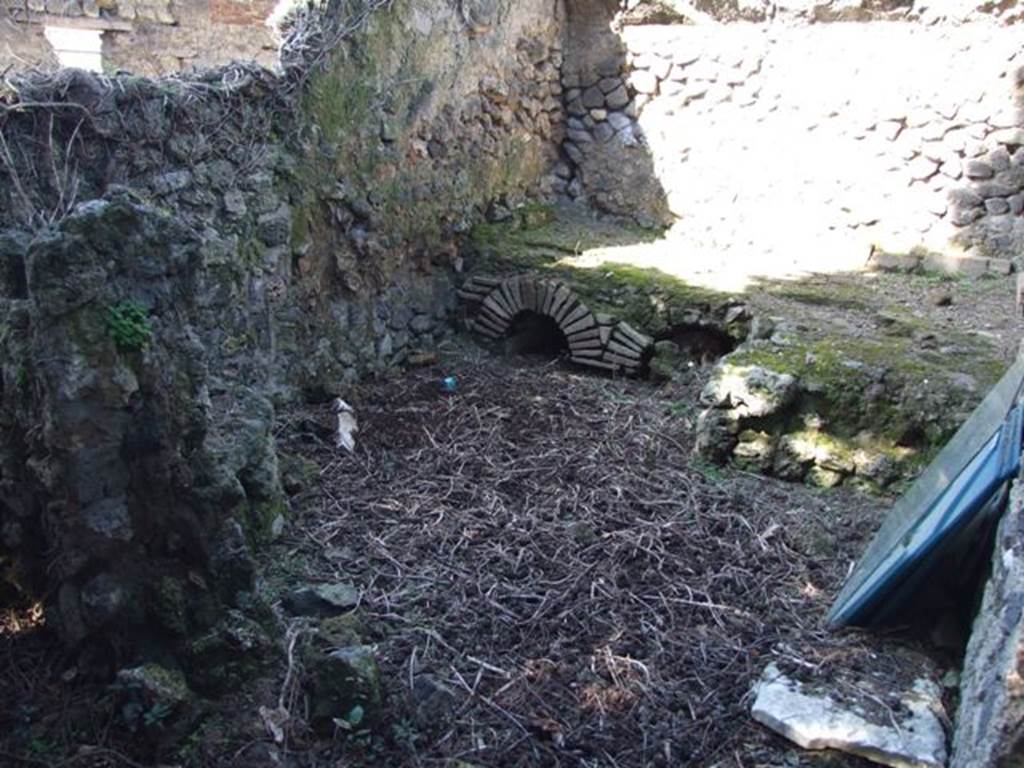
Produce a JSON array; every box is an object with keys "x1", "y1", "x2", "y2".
[{"x1": 562, "y1": 1, "x2": 1024, "y2": 263}]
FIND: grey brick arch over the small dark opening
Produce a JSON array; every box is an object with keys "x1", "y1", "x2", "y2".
[{"x1": 459, "y1": 275, "x2": 654, "y2": 374}]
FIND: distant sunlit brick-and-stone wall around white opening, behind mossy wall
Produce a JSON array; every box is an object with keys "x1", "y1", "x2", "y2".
[{"x1": 0, "y1": 0, "x2": 279, "y2": 76}]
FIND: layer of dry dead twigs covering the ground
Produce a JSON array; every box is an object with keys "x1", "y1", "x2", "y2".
[{"x1": 283, "y1": 350, "x2": 897, "y2": 766}]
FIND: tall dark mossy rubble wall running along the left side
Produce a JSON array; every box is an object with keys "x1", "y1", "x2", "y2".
[{"x1": 0, "y1": 0, "x2": 560, "y2": 690}]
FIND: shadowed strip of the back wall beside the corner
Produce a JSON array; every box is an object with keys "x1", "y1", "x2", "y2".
[{"x1": 558, "y1": 0, "x2": 671, "y2": 226}]
